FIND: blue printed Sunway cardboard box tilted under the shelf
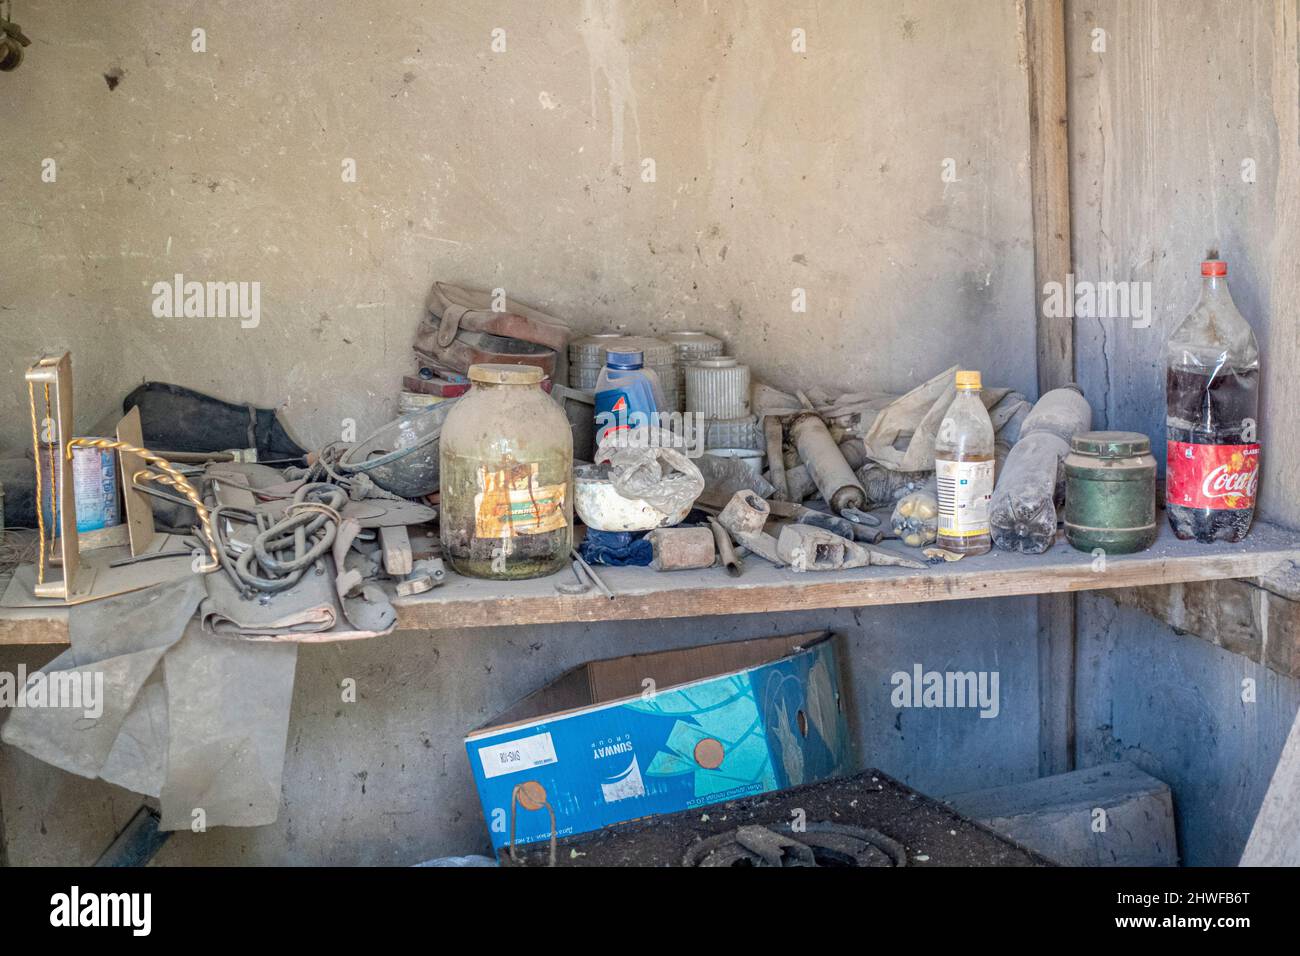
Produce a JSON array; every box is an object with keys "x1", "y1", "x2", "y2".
[{"x1": 465, "y1": 632, "x2": 848, "y2": 851}]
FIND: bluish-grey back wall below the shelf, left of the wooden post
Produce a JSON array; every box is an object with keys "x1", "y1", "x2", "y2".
[{"x1": 0, "y1": 598, "x2": 1039, "y2": 865}]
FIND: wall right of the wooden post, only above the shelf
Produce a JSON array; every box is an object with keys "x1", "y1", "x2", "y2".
[{"x1": 1067, "y1": 0, "x2": 1300, "y2": 527}]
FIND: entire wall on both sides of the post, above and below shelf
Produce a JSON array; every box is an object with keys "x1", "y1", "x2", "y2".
[{"x1": 0, "y1": 0, "x2": 1300, "y2": 864}]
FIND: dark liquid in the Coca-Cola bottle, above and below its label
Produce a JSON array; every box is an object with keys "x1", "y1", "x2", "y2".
[{"x1": 1165, "y1": 365, "x2": 1260, "y2": 544}]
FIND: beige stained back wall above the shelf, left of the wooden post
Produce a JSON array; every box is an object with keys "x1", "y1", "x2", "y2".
[{"x1": 0, "y1": 0, "x2": 1034, "y2": 447}]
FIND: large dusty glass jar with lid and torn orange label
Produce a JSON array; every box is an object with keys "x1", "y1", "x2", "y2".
[{"x1": 438, "y1": 365, "x2": 573, "y2": 580}]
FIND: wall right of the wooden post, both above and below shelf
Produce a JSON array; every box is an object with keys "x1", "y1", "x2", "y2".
[{"x1": 1067, "y1": 0, "x2": 1300, "y2": 865}]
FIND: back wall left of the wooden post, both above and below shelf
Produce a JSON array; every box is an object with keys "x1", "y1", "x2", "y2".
[{"x1": 0, "y1": 0, "x2": 1039, "y2": 864}]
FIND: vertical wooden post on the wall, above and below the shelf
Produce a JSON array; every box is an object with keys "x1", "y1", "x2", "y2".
[{"x1": 1024, "y1": 0, "x2": 1075, "y2": 777}]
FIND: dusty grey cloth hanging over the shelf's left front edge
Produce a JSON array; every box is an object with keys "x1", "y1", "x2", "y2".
[{"x1": 0, "y1": 574, "x2": 298, "y2": 830}]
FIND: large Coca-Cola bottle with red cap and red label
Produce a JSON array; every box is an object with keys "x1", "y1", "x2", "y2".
[{"x1": 1165, "y1": 252, "x2": 1260, "y2": 542}]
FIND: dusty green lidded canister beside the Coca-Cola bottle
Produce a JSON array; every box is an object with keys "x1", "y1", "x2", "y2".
[{"x1": 1065, "y1": 432, "x2": 1156, "y2": 554}]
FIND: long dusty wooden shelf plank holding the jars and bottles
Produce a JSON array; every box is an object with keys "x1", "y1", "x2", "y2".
[{"x1": 0, "y1": 522, "x2": 1300, "y2": 644}]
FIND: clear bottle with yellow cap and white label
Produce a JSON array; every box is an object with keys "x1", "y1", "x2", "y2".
[{"x1": 935, "y1": 372, "x2": 993, "y2": 554}]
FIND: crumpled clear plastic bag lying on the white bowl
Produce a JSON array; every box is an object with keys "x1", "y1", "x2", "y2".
[{"x1": 595, "y1": 427, "x2": 705, "y2": 516}]
